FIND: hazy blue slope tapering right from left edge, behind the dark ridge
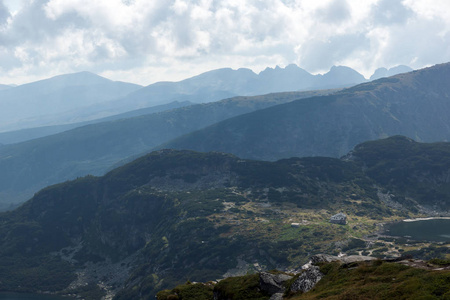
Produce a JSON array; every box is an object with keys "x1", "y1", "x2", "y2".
[{"x1": 0, "y1": 90, "x2": 333, "y2": 209}]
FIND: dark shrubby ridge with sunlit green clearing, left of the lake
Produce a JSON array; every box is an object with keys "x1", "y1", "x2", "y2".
[{"x1": 0, "y1": 136, "x2": 450, "y2": 300}]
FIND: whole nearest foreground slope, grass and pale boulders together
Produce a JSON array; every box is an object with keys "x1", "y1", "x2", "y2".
[{"x1": 157, "y1": 254, "x2": 450, "y2": 300}]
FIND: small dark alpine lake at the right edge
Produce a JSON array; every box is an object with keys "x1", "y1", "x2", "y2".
[{"x1": 384, "y1": 219, "x2": 450, "y2": 243}]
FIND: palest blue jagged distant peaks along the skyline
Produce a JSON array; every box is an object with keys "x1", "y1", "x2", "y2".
[{"x1": 105, "y1": 64, "x2": 412, "y2": 108}]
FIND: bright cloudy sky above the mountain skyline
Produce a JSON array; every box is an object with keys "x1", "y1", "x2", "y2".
[{"x1": 0, "y1": 0, "x2": 450, "y2": 85}]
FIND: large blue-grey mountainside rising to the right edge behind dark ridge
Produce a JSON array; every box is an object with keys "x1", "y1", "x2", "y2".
[{"x1": 160, "y1": 63, "x2": 450, "y2": 160}]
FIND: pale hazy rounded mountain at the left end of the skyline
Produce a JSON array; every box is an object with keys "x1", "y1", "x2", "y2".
[{"x1": 0, "y1": 72, "x2": 141, "y2": 132}]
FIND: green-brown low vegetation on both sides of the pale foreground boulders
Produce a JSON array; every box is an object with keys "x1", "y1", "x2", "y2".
[{"x1": 157, "y1": 260, "x2": 450, "y2": 300}]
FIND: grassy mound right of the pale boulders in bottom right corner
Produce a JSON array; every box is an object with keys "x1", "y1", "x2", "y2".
[{"x1": 296, "y1": 261, "x2": 450, "y2": 300}]
